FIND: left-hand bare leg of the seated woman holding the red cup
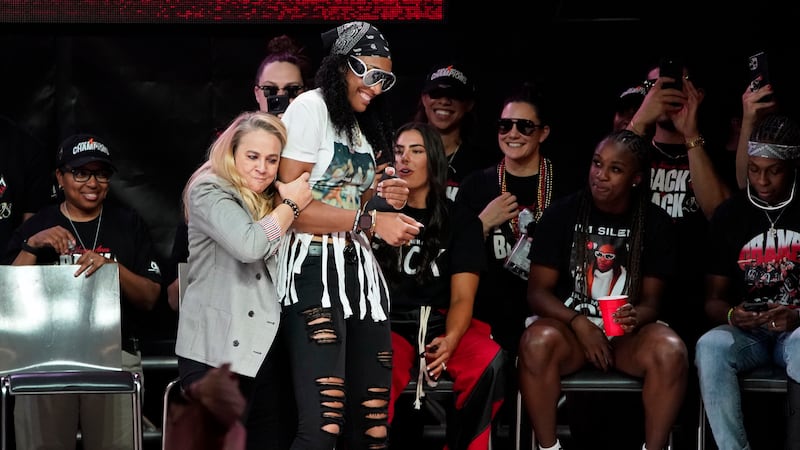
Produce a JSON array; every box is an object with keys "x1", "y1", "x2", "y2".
[{"x1": 518, "y1": 319, "x2": 585, "y2": 447}]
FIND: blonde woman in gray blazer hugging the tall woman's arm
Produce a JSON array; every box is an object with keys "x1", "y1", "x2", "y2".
[{"x1": 175, "y1": 112, "x2": 311, "y2": 442}]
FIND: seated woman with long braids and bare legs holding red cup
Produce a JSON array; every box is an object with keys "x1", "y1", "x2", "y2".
[{"x1": 519, "y1": 130, "x2": 688, "y2": 449}]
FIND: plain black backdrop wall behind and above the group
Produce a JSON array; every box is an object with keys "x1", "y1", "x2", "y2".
[{"x1": 0, "y1": 0, "x2": 800, "y2": 342}]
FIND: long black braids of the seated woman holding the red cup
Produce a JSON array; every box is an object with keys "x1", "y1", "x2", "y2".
[{"x1": 574, "y1": 130, "x2": 651, "y2": 304}]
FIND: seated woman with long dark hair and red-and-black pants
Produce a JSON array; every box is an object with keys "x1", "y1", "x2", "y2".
[{"x1": 372, "y1": 122, "x2": 505, "y2": 450}]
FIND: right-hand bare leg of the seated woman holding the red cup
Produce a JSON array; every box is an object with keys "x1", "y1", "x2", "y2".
[{"x1": 613, "y1": 323, "x2": 689, "y2": 450}]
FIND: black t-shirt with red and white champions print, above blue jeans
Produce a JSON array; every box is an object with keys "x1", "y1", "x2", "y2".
[{"x1": 707, "y1": 186, "x2": 800, "y2": 306}]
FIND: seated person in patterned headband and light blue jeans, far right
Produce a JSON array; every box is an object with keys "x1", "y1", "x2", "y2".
[{"x1": 695, "y1": 111, "x2": 800, "y2": 450}]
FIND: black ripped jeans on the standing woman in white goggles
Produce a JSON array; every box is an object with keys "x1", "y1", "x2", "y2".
[{"x1": 281, "y1": 247, "x2": 392, "y2": 450}]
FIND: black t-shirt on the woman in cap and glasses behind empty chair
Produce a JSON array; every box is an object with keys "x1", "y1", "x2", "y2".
[{"x1": 4, "y1": 201, "x2": 161, "y2": 339}]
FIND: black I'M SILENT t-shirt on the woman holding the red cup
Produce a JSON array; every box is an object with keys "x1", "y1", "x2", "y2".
[{"x1": 530, "y1": 192, "x2": 675, "y2": 323}]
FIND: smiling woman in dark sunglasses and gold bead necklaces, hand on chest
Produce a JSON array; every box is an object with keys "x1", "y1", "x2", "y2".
[{"x1": 457, "y1": 84, "x2": 556, "y2": 352}]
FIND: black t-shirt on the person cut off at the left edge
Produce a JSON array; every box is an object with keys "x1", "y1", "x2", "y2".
[{"x1": 0, "y1": 117, "x2": 55, "y2": 251}]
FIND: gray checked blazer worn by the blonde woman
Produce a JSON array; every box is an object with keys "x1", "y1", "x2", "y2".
[{"x1": 175, "y1": 174, "x2": 281, "y2": 377}]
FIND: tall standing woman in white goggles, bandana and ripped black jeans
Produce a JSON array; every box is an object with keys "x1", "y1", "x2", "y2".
[{"x1": 276, "y1": 22, "x2": 419, "y2": 449}]
